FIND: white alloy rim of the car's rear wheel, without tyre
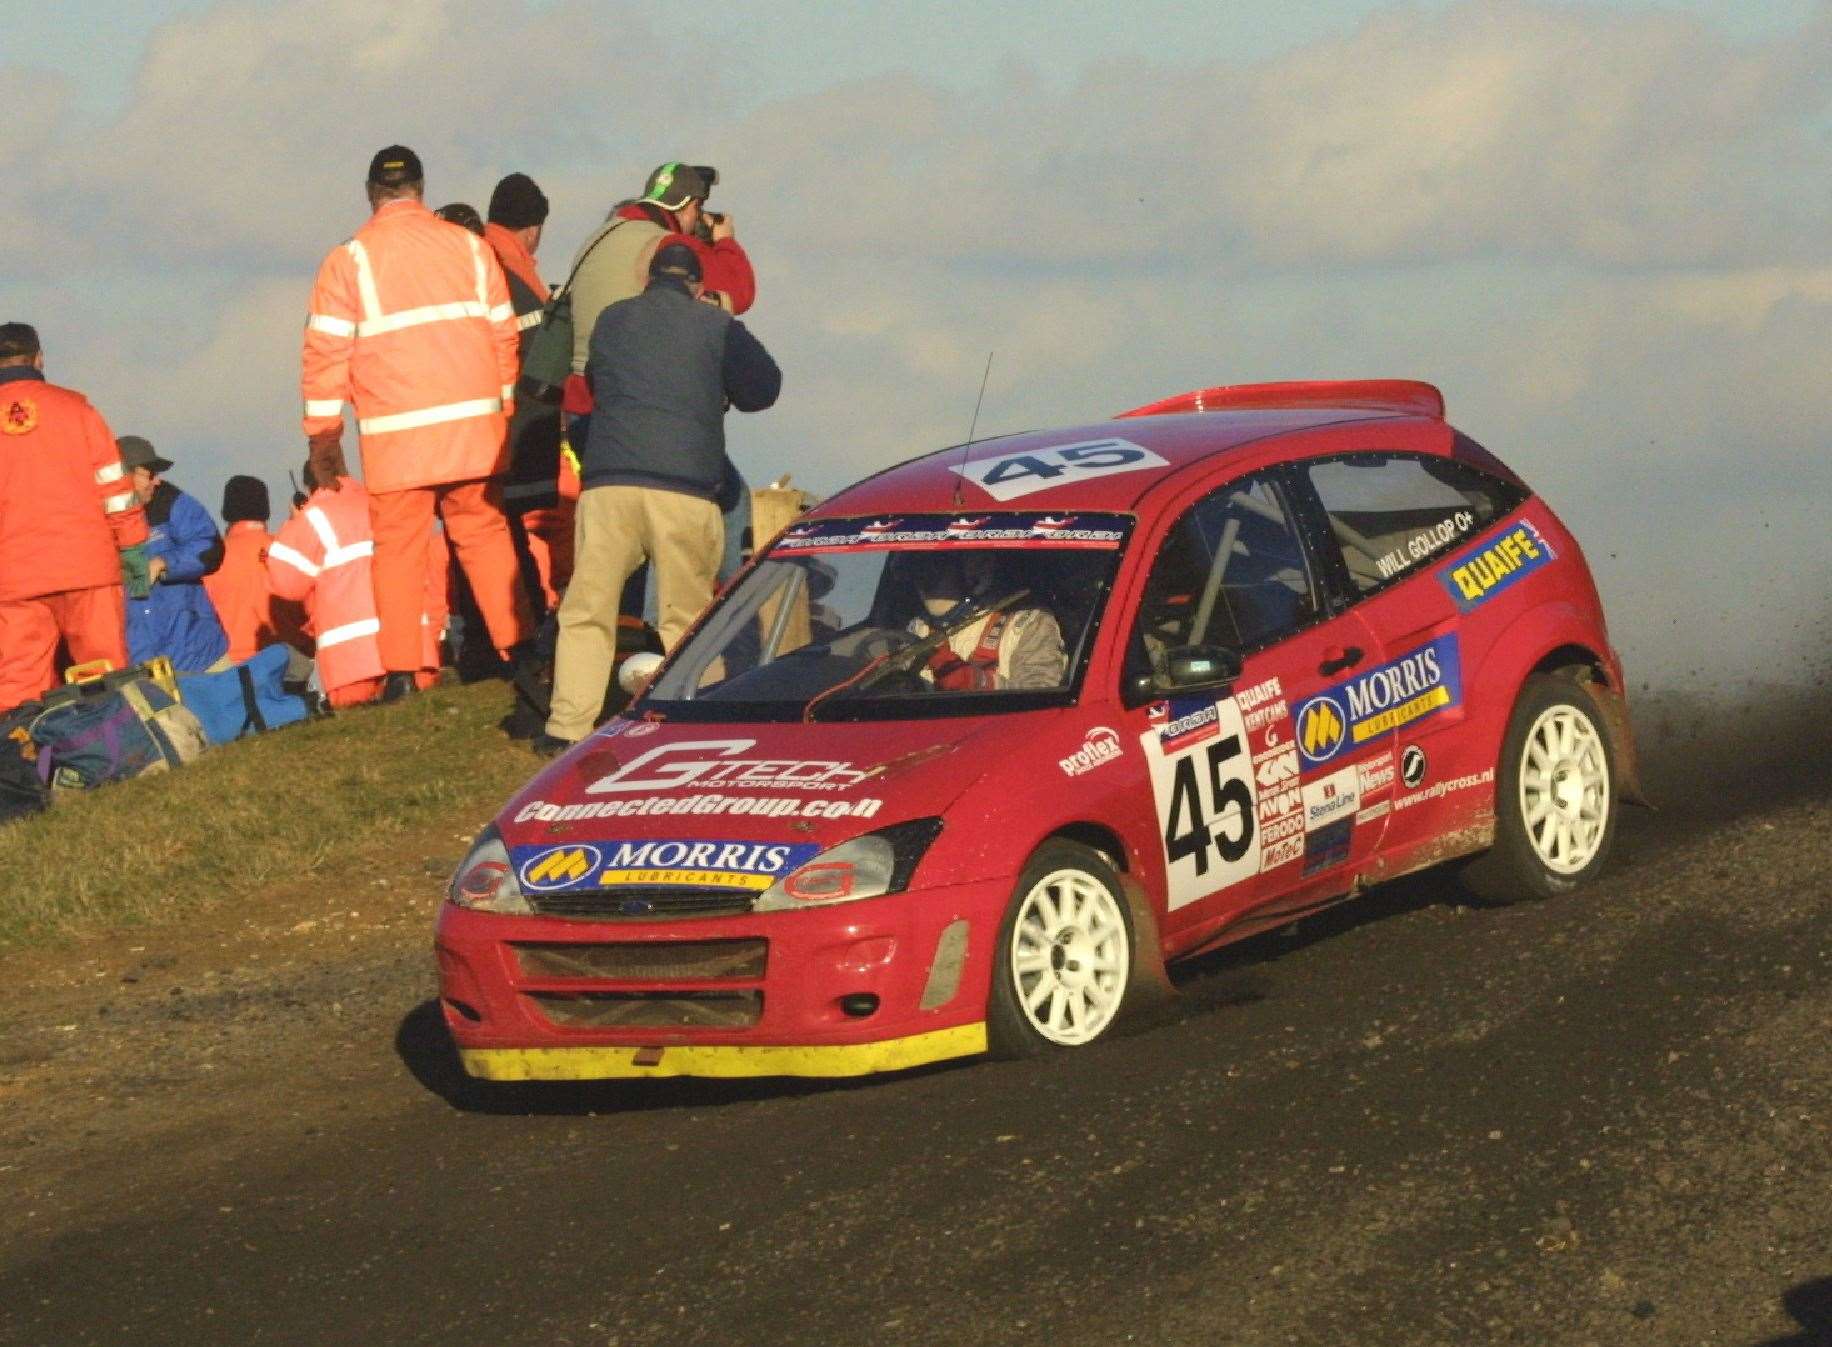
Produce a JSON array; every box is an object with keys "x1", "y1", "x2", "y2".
[{"x1": 1521, "y1": 706, "x2": 1614, "y2": 874}]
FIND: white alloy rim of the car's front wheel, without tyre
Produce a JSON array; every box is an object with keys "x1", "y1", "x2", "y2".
[{"x1": 1006, "y1": 867, "x2": 1132, "y2": 1046}]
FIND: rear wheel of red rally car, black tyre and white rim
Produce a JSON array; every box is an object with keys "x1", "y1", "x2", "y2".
[{"x1": 1464, "y1": 674, "x2": 1621, "y2": 903}]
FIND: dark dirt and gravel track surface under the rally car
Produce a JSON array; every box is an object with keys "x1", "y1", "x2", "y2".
[{"x1": 0, "y1": 707, "x2": 1832, "y2": 1347}]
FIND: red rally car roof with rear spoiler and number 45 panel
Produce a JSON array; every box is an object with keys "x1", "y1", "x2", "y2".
[{"x1": 812, "y1": 379, "x2": 1444, "y2": 517}]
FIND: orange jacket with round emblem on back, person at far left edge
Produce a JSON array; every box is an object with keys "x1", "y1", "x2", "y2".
[{"x1": 0, "y1": 367, "x2": 147, "y2": 603}]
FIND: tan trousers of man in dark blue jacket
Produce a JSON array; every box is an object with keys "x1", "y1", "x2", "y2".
[{"x1": 548, "y1": 486, "x2": 725, "y2": 739}]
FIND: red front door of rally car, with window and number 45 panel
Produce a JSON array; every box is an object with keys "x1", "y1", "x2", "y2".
[{"x1": 1121, "y1": 469, "x2": 1379, "y2": 951}]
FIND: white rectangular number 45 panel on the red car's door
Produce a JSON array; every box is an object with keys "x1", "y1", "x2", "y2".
[{"x1": 1140, "y1": 698, "x2": 1260, "y2": 911}]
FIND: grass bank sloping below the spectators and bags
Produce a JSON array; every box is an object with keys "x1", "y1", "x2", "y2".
[{"x1": 0, "y1": 684, "x2": 537, "y2": 949}]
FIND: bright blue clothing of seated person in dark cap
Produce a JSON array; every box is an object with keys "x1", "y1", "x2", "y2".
[{"x1": 126, "y1": 482, "x2": 229, "y2": 673}]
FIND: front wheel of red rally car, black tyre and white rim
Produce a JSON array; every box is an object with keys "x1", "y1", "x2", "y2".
[{"x1": 986, "y1": 841, "x2": 1132, "y2": 1057}]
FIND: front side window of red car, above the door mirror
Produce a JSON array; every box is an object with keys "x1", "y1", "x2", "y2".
[{"x1": 1129, "y1": 475, "x2": 1317, "y2": 685}]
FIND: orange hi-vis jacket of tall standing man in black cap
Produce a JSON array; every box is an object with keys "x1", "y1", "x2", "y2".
[{"x1": 300, "y1": 198, "x2": 518, "y2": 495}]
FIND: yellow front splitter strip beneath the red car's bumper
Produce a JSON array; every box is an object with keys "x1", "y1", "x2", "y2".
[{"x1": 458, "y1": 1021, "x2": 986, "y2": 1081}]
